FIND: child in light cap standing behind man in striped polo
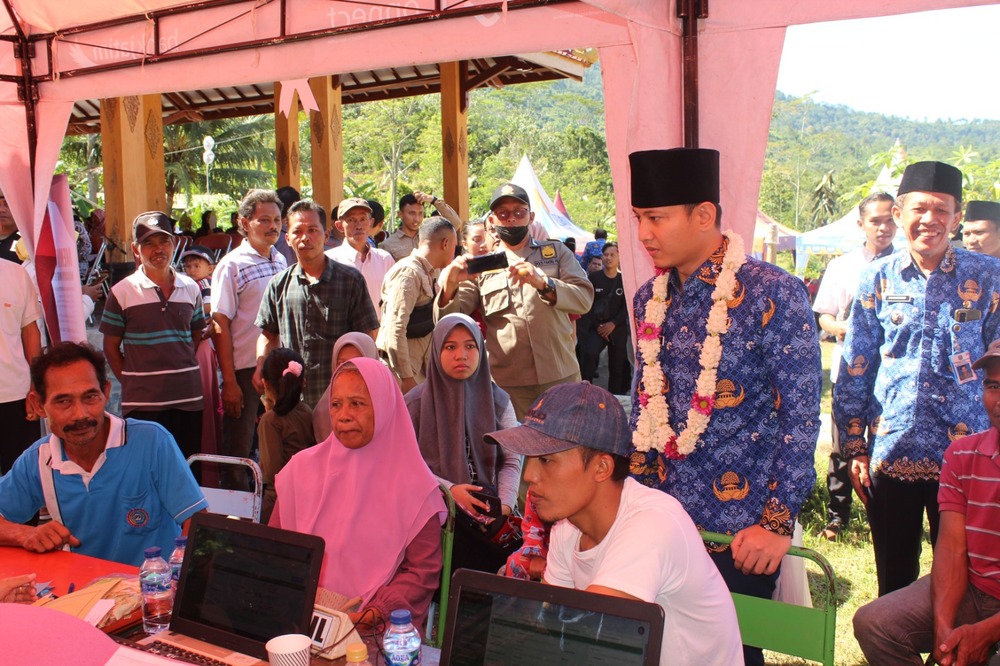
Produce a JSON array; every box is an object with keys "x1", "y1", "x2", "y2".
[{"x1": 181, "y1": 245, "x2": 222, "y2": 462}]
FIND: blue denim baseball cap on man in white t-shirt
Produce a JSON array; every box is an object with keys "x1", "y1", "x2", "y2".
[{"x1": 486, "y1": 382, "x2": 632, "y2": 456}]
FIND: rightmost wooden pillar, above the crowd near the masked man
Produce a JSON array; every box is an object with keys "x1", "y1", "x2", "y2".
[{"x1": 439, "y1": 60, "x2": 469, "y2": 221}]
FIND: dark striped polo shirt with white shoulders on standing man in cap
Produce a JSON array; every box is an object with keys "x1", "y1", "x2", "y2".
[{"x1": 101, "y1": 267, "x2": 205, "y2": 415}]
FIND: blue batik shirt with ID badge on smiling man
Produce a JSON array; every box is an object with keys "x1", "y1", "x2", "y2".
[{"x1": 833, "y1": 247, "x2": 1000, "y2": 481}]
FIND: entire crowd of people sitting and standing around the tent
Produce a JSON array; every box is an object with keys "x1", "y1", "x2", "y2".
[{"x1": 0, "y1": 149, "x2": 1000, "y2": 665}]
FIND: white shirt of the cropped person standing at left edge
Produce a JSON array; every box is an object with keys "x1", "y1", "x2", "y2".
[{"x1": 0, "y1": 259, "x2": 42, "y2": 402}]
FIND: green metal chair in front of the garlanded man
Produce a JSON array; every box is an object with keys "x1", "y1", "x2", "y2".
[{"x1": 701, "y1": 532, "x2": 837, "y2": 666}]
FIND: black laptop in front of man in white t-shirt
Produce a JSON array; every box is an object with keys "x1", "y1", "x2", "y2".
[{"x1": 441, "y1": 569, "x2": 663, "y2": 666}]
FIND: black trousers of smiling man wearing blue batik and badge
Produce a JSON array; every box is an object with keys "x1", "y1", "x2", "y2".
[{"x1": 868, "y1": 475, "x2": 938, "y2": 597}]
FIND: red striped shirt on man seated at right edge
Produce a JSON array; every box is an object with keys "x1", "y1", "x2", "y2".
[{"x1": 938, "y1": 428, "x2": 1000, "y2": 599}]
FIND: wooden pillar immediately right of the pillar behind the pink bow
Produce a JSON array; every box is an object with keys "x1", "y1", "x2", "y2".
[{"x1": 309, "y1": 76, "x2": 344, "y2": 221}]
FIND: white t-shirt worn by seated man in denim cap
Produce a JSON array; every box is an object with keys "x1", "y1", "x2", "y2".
[{"x1": 545, "y1": 478, "x2": 743, "y2": 666}]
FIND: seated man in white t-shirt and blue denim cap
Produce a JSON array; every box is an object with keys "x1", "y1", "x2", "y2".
[{"x1": 487, "y1": 382, "x2": 743, "y2": 666}]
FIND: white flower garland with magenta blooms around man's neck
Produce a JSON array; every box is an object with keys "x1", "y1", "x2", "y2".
[{"x1": 632, "y1": 231, "x2": 746, "y2": 460}]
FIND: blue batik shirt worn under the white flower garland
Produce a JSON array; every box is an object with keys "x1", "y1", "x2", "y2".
[{"x1": 631, "y1": 240, "x2": 822, "y2": 535}]
